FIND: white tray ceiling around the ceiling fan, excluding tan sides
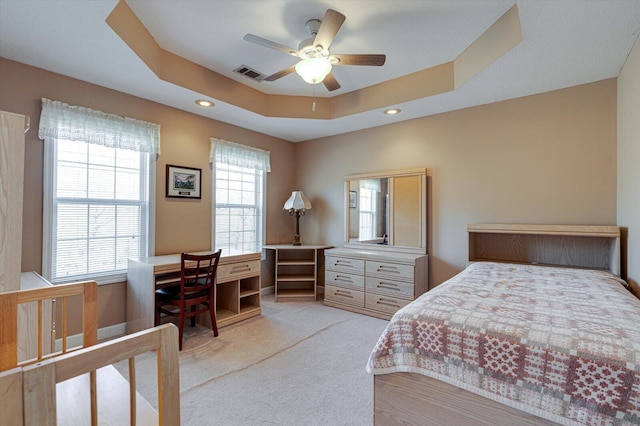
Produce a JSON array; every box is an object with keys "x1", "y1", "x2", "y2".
[{"x1": 0, "y1": 0, "x2": 640, "y2": 142}]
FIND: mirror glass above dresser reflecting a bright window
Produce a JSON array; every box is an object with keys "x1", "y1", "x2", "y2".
[{"x1": 349, "y1": 178, "x2": 389, "y2": 244}]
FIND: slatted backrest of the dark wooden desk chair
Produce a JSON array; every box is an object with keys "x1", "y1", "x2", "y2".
[{"x1": 180, "y1": 250, "x2": 222, "y2": 294}]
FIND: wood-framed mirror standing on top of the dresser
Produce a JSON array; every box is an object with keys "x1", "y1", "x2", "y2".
[{"x1": 345, "y1": 169, "x2": 427, "y2": 254}]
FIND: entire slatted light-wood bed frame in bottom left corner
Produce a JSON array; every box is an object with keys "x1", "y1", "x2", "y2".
[{"x1": 0, "y1": 281, "x2": 180, "y2": 426}]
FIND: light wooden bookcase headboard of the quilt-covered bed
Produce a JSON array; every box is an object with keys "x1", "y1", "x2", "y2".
[{"x1": 467, "y1": 223, "x2": 620, "y2": 276}]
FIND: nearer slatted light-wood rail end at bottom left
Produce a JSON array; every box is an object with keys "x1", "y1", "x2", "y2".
[{"x1": 22, "y1": 324, "x2": 180, "y2": 426}]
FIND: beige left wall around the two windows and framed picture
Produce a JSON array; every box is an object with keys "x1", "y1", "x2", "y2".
[{"x1": 0, "y1": 58, "x2": 295, "y2": 327}]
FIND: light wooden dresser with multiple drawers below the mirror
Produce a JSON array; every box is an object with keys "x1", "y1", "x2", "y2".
[{"x1": 324, "y1": 248, "x2": 428, "y2": 319}]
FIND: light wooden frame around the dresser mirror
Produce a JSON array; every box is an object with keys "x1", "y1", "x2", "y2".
[{"x1": 344, "y1": 168, "x2": 427, "y2": 254}]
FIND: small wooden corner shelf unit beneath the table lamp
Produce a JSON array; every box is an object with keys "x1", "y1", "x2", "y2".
[{"x1": 264, "y1": 244, "x2": 331, "y2": 302}]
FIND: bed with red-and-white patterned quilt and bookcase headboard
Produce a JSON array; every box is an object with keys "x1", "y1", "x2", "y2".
[{"x1": 367, "y1": 224, "x2": 640, "y2": 425}]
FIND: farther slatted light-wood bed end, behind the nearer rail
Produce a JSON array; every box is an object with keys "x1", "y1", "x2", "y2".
[{"x1": 0, "y1": 281, "x2": 98, "y2": 371}]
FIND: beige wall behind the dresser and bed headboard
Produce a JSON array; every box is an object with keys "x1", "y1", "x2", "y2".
[{"x1": 296, "y1": 79, "x2": 616, "y2": 286}]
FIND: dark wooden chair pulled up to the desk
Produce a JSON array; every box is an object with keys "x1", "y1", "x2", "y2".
[{"x1": 155, "y1": 250, "x2": 222, "y2": 350}]
